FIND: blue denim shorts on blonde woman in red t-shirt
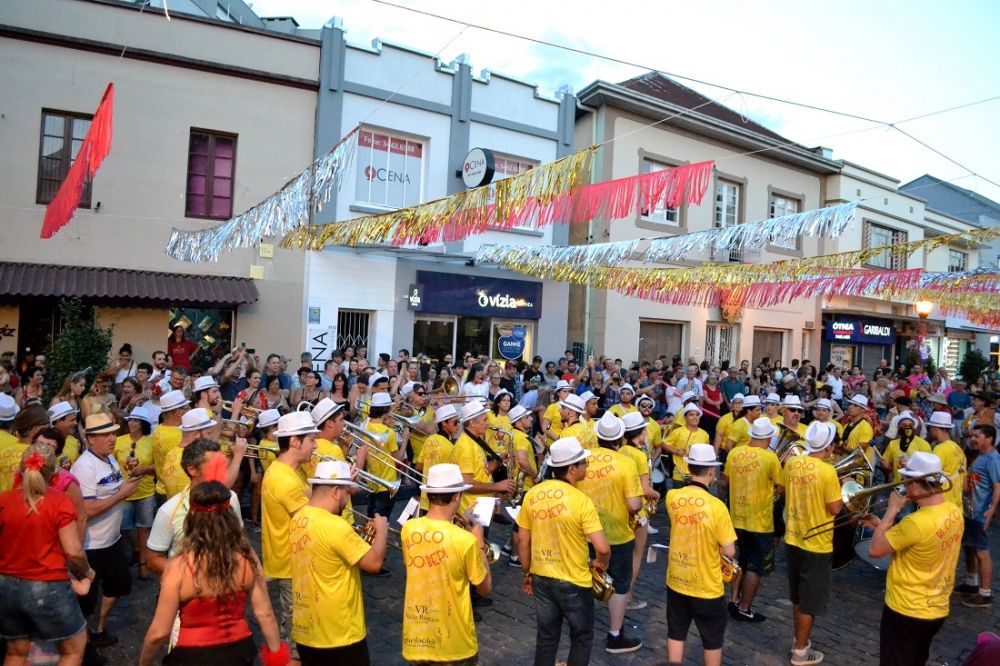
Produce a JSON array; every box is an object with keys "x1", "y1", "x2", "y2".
[{"x1": 0, "y1": 576, "x2": 87, "y2": 641}]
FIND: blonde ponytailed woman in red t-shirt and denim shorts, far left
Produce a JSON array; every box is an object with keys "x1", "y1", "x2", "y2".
[{"x1": 0, "y1": 445, "x2": 94, "y2": 664}]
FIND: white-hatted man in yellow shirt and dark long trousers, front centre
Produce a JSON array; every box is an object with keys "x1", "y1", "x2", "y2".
[{"x1": 517, "y1": 437, "x2": 611, "y2": 664}]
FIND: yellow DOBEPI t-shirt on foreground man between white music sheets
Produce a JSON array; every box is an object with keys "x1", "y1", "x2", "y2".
[{"x1": 401, "y1": 517, "x2": 486, "y2": 662}]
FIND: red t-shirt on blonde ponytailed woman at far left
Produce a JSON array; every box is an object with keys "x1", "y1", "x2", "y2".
[{"x1": 0, "y1": 488, "x2": 77, "y2": 580}]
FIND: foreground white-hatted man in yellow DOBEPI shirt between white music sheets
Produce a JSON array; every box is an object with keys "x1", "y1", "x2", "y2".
[{"x1": 400, "y1": 463, "x2": 493, "y2": 663}]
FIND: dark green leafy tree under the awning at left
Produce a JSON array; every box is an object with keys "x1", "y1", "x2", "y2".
[{"x1": 44, "y1": 298, "x2": 112, "y2": 404}]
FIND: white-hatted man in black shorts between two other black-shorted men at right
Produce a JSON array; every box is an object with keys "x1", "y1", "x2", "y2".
[{"x1": 723, "y1": 417, "x2": 781, "y2": 623}]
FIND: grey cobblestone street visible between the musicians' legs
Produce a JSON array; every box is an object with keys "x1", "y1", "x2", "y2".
[{"x1": 88, "y1": 508, "x2": 1000, "y2": 666}]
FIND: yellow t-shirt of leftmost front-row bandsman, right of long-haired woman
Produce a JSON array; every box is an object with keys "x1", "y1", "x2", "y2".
[{"x1": 290, "y1": 506, "x2": 371, "y2": 648}]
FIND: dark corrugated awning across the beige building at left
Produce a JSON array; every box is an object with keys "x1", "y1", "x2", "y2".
[{"x1": 0, "y1": 262, "x2": 260, "y2": 306}]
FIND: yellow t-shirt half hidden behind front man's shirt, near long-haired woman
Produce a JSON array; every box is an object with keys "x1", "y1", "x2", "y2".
[{"x1": 260, "y1": 460, "x2": 308, "y2": 580}]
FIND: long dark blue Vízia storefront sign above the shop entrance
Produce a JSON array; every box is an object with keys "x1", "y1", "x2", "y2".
[{"x1": 408, "y1": 271, "x2": 542, "y2": 320}]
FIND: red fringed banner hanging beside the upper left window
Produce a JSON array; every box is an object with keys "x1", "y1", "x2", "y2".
[{"x1": 42, "y1": 83, "x2": 115, "y2": 238}]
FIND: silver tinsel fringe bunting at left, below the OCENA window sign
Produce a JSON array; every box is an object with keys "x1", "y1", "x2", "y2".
[{"x1": 166, "y1": 128, "x2": 358, "y2": 261}]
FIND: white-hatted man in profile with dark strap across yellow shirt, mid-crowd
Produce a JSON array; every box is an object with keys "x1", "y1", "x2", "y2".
[{"x1": 451, "y1": 400, "x2": 514, "y2": 513}]
